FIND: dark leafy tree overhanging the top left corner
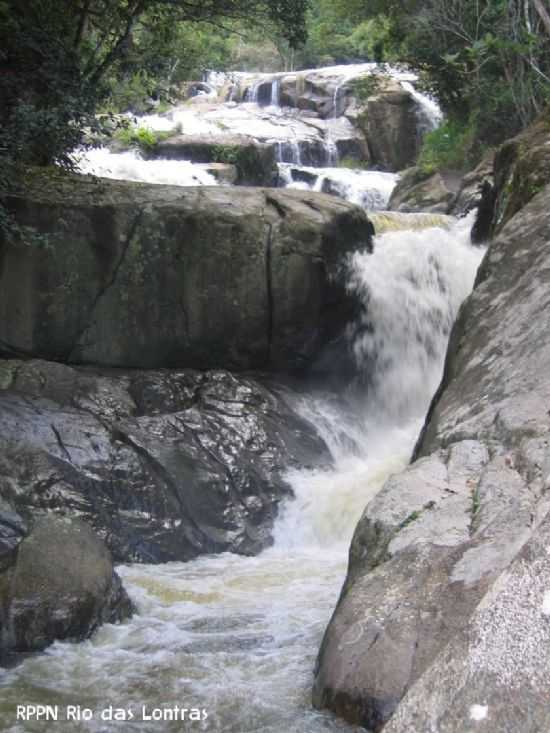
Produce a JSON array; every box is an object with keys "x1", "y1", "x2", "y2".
[{"x1": 0, "y1": 0, "x2": 307, "y2": 164}]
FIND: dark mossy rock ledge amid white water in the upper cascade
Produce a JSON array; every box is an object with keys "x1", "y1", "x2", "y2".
[{"x1": 151, "y1": 135, "x2": 277, "y2": 186}]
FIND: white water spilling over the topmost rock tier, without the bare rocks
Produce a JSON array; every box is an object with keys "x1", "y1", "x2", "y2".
[{"x1": 124, "y1": 63, "x2": 441, "y2": 166}]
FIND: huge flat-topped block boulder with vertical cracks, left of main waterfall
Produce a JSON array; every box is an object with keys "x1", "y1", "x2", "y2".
[{"x1": 0, "y1": 176, "x2": 370, "y2": 370}]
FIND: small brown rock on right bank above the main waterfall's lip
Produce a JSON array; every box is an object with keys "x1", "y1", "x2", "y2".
[{"x1": 388, "y1": 166, "x2": 461, "y2": 214}]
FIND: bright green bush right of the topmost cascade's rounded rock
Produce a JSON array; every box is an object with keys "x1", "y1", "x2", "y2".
[{"x1": 418, "y1": 119, "x2": 480, "y2": 175}]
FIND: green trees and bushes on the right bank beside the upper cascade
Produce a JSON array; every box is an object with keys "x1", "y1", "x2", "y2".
[{"x1": 320, "y1": 0, "x2": 550, "y2": 156}]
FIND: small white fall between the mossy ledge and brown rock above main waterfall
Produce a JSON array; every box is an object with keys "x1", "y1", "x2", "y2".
[{"x1": 279, "y1": 164, "x2": 399, "y2": 211}]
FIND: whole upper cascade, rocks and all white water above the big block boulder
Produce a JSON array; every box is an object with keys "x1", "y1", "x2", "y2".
[{"x1": 79, "y1": 63, "x2": 442, "y2": 211}]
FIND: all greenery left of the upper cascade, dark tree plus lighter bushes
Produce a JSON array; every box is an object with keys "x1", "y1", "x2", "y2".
[{"x1": 0, "y1": 0, "x2": 307, "y2": 234}]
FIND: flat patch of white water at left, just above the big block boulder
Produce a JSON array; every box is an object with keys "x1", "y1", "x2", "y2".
[{"x1": 75, "y1": 148, "x2": 218, "y2": 186}]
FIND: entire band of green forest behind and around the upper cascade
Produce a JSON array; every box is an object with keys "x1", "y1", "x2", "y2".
[{"x1": 0, "y1": 0, "x2": 550, "y2": 183}]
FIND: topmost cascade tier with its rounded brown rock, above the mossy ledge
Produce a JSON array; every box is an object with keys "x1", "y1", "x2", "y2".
[{"x1": 138, "y1": 63, "x2": 442, "y2": 171}]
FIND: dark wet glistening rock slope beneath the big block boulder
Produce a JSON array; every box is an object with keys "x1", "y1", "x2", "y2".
[{"x1": 0, "y1": 360, "x2": 330, "y2": 562}]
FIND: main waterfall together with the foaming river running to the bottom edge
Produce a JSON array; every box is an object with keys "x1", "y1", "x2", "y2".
[{"x1": 0, "y1": 214, "x2": 482, "y2": 733}]
